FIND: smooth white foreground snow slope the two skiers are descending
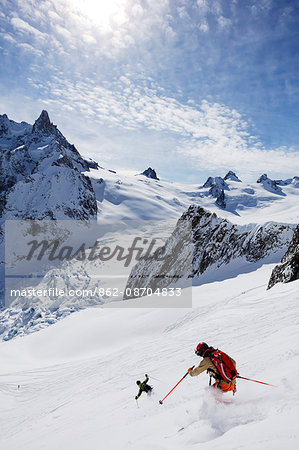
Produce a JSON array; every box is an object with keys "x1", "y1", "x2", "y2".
[{"x1": 0, "y1": 265, "x2": 299, "y2": 450}]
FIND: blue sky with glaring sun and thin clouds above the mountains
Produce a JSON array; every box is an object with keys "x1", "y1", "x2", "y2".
[{"x1": 0, "y1": 0, "x2": 299, "y2": 183}]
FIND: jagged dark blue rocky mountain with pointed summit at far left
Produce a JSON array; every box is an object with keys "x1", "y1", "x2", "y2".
[{"x1": 0, "y1": 111, "x2": 97, "y2": 220}]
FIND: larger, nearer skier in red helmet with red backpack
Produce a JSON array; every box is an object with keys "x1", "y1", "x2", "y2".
[{"x1": 188, "y1": 342, "x2": 238, "y2": 393}]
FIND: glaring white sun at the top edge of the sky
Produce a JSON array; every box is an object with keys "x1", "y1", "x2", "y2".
[{"x1": 70, "y1": 0, "x2": 128, "y2": 31}]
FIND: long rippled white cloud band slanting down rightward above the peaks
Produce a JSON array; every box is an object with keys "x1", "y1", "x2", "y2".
[{"x1": 26, "y1": 76, "x2": 299, "y2": 175}]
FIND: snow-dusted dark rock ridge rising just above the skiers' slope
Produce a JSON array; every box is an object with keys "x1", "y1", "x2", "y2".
[{"x1": 126, "y1": 206, "x2": 295, "y2": 298}]
